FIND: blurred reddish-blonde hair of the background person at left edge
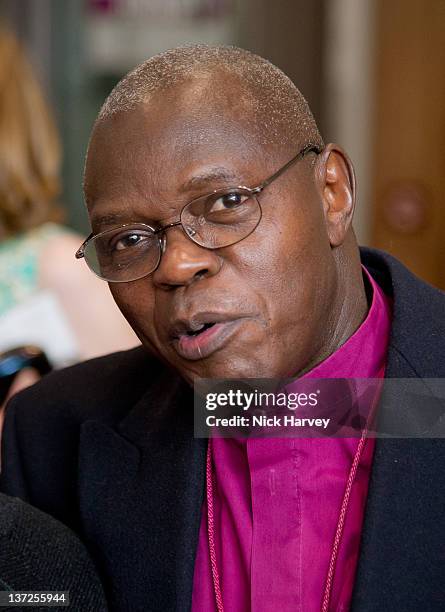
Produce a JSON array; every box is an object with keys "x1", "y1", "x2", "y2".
[{"x1": 0, "y1": 27, "x2": 62, "y2": 238}]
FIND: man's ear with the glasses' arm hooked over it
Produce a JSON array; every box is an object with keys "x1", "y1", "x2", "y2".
[{"x1": 316, "y1": 143, "x2": 355, "y2": 247}]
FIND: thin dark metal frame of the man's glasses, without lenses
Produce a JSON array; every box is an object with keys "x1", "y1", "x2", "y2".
[{"x1": 75, "y1": 143, "x2": 323, "y2": 283}]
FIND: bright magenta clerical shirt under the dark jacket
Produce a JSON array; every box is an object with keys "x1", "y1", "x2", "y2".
[{"x1": 192, "y1": 271, "x2": 391, "y2": 612}]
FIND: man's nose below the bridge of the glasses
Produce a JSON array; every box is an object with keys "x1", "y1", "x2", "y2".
[{"x1": 153, "y1": 226, "x2": 222, "y2": 289}]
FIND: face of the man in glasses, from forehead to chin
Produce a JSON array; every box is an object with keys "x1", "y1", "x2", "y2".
[{"x1": 85, "y1": 82, "x2": 335, "y2": 381}]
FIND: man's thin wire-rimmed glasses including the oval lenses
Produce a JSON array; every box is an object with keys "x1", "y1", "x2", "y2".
[{"x1": 76, "y1": 144, "x2": 321, "y2": 283}]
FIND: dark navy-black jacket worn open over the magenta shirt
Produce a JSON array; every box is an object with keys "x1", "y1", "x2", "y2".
[{"x1": 2, "y1": 249, "x2": 445, "y2": 612}]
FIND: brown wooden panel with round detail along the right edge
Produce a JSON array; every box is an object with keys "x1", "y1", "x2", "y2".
[{"x1": 371, "y1": 0, "x2": 445, "y2": 289}]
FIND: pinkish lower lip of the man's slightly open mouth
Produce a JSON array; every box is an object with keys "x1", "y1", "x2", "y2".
[{"x1": 174, "y1": 319, "x2": 242, "y2": 361}]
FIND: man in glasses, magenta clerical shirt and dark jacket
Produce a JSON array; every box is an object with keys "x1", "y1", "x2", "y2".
[{"x1": 2, "y1": 46, "x2": 445, "y2": 612}]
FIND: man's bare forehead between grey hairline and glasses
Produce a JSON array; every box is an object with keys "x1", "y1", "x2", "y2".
[{"x1": 81, "y1": 81, "x2": 273, "y2": 220}]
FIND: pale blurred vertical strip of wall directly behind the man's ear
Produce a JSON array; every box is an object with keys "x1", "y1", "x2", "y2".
[{"x1": 323, "y1": 0, "x2": 376, "y2": 245}]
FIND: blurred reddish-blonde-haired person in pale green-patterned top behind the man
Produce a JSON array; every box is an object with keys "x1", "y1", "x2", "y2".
[{"x1": 0, "y1": 27, "x2": 138, "y2": 390}]
